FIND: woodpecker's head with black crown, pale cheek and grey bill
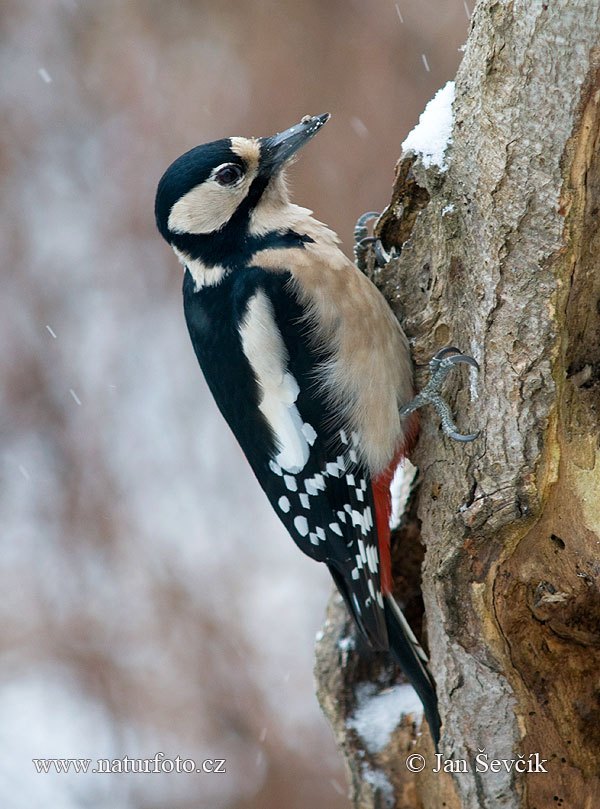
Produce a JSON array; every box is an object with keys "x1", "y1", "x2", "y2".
[{"x1": 155, "y1": 113, "x2": 329, "y2": 249}]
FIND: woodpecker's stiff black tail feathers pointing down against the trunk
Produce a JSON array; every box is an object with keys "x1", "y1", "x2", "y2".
[{"x1": 384, "y1": 593, "x2": 441, "y2": 750}]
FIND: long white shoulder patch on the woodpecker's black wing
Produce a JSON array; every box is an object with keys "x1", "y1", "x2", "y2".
[{"x1": 240, "y1": 290, "x2": 312, "y2": 474}]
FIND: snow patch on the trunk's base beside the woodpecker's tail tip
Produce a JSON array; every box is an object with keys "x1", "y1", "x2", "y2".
[{"x1": 347, "y1": 683, "x2": 423, "y2": 753}]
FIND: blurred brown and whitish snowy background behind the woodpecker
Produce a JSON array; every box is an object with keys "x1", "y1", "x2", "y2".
[{"x1": 0, "y1": 0, "x2": 472, "y2": 809}]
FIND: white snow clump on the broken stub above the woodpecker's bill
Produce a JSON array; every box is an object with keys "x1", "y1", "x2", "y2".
[{"x1": 402, "y1": 81, "x2": 454, "y2": 170}]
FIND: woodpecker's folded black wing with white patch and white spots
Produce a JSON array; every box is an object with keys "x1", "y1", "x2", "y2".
[{"x1": 184, "y1": 268, "x2": 388, "y2": 649}]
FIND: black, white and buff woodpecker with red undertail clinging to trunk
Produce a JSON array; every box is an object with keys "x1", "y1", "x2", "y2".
[{"x1": 155, "y1": 114, "x2": 475, "y2": 743}]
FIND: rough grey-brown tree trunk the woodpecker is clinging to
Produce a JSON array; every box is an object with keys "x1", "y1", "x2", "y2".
[{"x1": 317, "y1": 0, "x2": 600, "y2": 809}]
